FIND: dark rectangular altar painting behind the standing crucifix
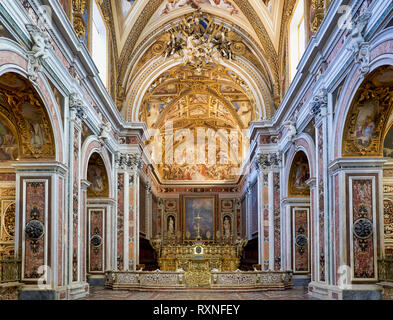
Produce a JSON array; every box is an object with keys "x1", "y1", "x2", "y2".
[{"x1": 183, "y1": 197, "x2": 215, "y2": 241}]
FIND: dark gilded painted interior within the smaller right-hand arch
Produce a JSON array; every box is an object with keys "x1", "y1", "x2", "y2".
[{"x1": 288, "y1": 151, "x2": 310, "y2": 196}]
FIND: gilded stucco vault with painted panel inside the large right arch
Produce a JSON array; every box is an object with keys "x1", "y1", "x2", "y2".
[{"x1": 343, "y1": 67, "x2": 393, "y2": 157}]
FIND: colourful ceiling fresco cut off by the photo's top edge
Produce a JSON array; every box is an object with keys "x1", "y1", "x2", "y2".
[{"x1": 157, "y1": 0, "x2": 239, "y2": 17}]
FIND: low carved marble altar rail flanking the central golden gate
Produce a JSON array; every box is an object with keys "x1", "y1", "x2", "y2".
[{"x1": 105, "y1": 271, "x2": 292, "y2": 291}]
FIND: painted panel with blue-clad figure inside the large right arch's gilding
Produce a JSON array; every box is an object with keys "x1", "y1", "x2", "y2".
[{"x1": 354, "y1": 100, "x2": 379, "y2": 148}]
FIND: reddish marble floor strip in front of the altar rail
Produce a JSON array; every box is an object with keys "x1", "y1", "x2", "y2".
[{"x1": 87, "y1": 287, "x2": 315, "y2": 300}]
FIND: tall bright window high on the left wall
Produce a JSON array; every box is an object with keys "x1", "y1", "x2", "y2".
[{"x1": 91, "y1": 1, "x2": 108, "y2": 87}]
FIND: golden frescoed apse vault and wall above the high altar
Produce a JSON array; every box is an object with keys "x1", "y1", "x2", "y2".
[{"x1": 139, "y1": 66, "x2": 253, "y2": 182}]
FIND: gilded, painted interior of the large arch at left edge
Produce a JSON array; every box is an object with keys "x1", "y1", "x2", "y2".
[{"x1": 0, "y1": 73, "x2": 55, "y2": 161}]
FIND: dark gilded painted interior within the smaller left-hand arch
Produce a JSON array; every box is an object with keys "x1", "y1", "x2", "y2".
[{"x1": 87, "y1": 153, "x2": 109, "y2": 197}]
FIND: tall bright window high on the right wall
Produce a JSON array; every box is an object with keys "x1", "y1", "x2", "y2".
[{"x1": 289, "y1": 0, "x2": 306, "y2": 81}]
